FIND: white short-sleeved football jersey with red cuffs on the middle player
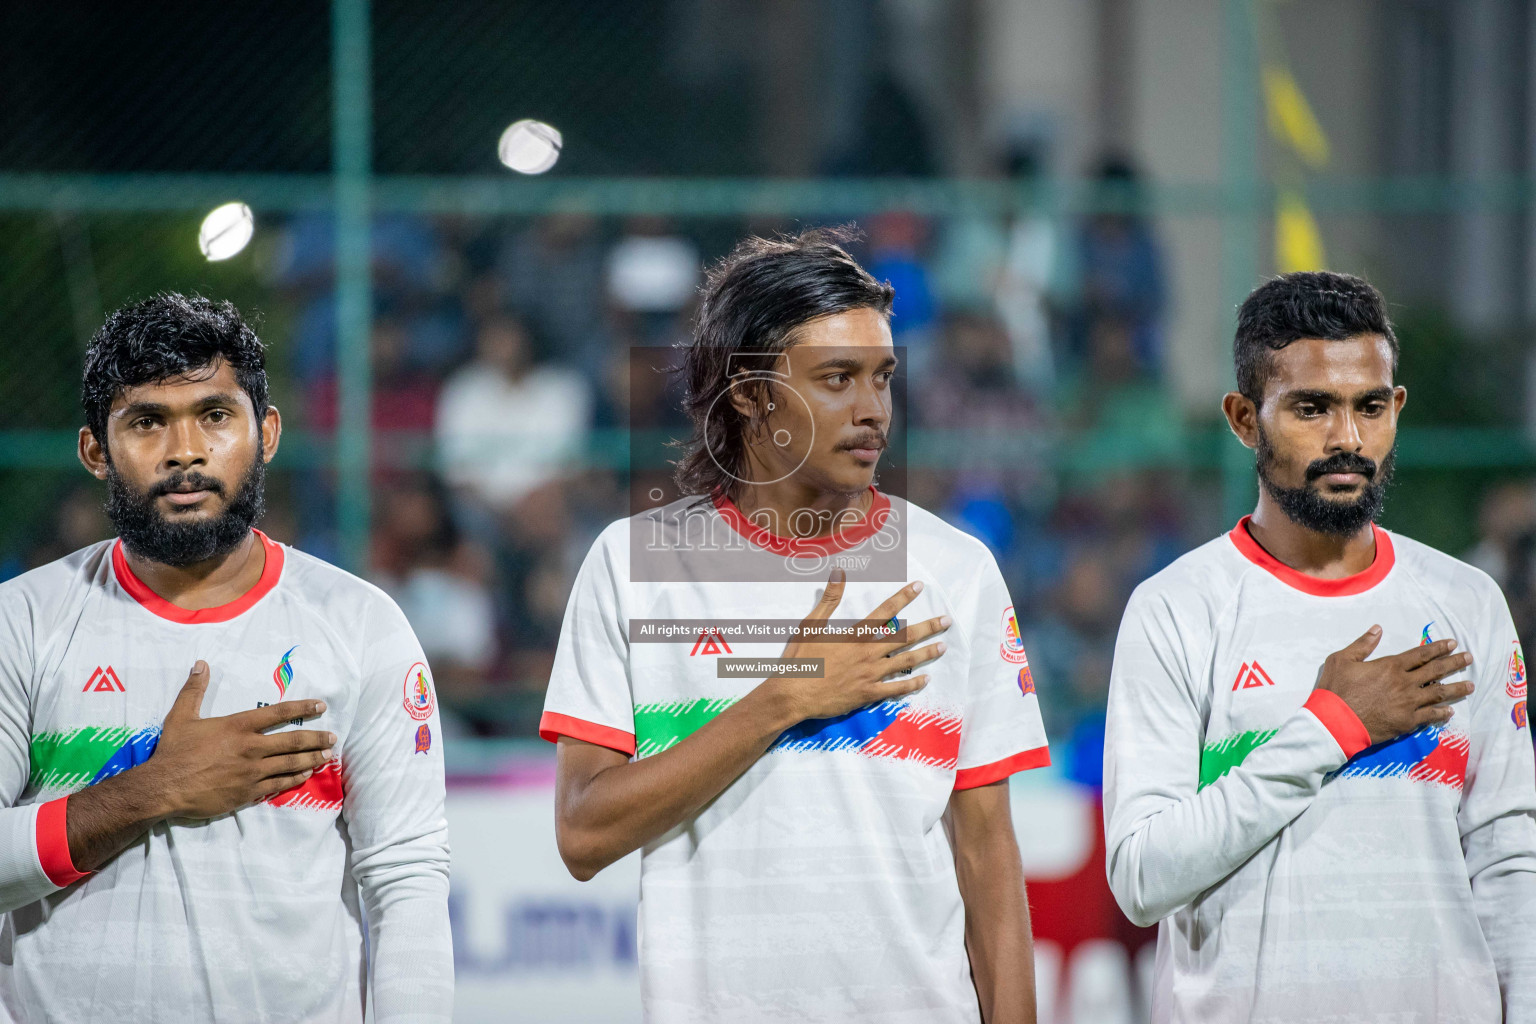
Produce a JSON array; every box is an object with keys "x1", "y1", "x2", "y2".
[{"x1": 541, "y1": 493, "x2": 1049, "y2": 1024}]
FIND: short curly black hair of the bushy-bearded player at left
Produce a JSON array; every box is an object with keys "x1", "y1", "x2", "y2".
[{"x1": 80, "y1": 292, "x2": 269, "y2": 448}]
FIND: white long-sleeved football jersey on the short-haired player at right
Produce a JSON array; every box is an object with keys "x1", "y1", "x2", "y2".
[{"x1": 1104, "y1": 519, "x2": 1536, "y2": 1024}]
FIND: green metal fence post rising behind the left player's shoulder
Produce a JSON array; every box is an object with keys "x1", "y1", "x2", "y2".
[{"x1": 330, "y1": 0, "x2": 373, "y2": 571}]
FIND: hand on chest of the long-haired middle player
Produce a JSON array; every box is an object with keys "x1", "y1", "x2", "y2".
[{"x1": 771, "y1": 570, "x2": 951, "y2": 722}]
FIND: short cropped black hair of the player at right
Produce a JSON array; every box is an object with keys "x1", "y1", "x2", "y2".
[{"x1": 1232, "y1": 270, "x2": 1398, "y2": 405}]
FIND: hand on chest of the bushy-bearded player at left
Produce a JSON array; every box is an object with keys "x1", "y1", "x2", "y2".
[{"x1": 144, "y1": 662, "x2": 336, "y2": 818}]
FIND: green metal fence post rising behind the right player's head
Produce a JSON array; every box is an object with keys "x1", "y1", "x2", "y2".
[{"x1": 1221, "y1": 0, "x2": 1263, "y2": 524}]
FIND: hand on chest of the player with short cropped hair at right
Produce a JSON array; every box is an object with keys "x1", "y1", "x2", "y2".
[{"x1": 1318, "y1": 626, "x2": 1473, "y2": 745}]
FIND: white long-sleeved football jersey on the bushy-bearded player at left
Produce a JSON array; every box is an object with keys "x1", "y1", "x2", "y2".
[{"x1": 0, "y1": 531, "x2": 453, "y2": 1024}]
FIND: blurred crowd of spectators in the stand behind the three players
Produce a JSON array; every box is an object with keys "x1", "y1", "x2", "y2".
[{"x1": 21, "y1": 158, "x2": 1536, "y2": 761}]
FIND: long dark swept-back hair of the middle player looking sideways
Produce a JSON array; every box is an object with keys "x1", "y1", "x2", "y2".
[{"x1": 674, "y1": 227, "x2": 895, "y2": 494}]
